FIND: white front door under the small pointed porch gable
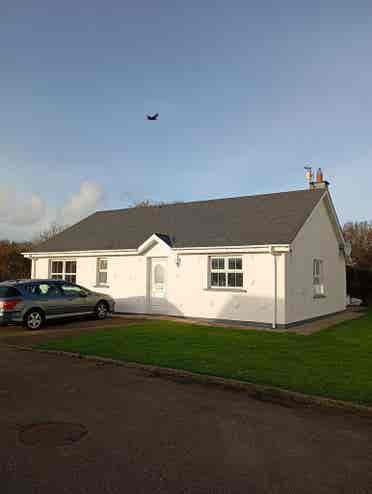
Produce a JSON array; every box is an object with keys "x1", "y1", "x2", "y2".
[{"x1": 150, "y1": 257, "x2": 167, "y2": 314}]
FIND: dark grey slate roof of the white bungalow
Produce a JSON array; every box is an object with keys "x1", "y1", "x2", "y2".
[{"x1": 34, "y1": 190, "x2": 324, "y2": 252}]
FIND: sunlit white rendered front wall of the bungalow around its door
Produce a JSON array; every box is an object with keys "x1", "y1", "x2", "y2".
[{"x1": 36, "y1": 244, "x2": 285, "y2": 324}]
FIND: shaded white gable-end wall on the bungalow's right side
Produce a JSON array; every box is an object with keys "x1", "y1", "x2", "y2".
[{"x1": 286, "y1": 200, "x2": 346, "y2": 322}]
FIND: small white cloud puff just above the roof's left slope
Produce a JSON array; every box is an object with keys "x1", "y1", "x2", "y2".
[{"x1": 60, "y1": 181, "x2": 104, "y2": 224}]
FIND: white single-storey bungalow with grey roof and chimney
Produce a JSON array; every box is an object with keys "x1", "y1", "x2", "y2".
[{"x1": 25, "y1": 174, "x2": 346, "y2": 327}]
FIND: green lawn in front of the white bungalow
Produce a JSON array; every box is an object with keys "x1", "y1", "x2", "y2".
[{"x1": 38, "y1": 311, "x2": 372, "y2": 404}]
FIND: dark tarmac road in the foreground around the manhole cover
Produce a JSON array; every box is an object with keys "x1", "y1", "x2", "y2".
[{"x1": 0, "y1": 346, "x2": 372, "y2": 494}]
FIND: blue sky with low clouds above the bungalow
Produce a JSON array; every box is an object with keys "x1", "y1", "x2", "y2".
[{"x1": 0, "y1": 0, "x2": 372, "y2": 239}]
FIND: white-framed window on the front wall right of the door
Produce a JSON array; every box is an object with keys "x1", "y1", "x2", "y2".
[{"x1": 210, "y1": 257, "x2": 243, "y2": 288}]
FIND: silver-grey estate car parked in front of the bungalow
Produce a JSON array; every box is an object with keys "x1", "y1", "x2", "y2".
[{"x1": 0, "y1": 280, "x2": 115, "y2": 330}]
